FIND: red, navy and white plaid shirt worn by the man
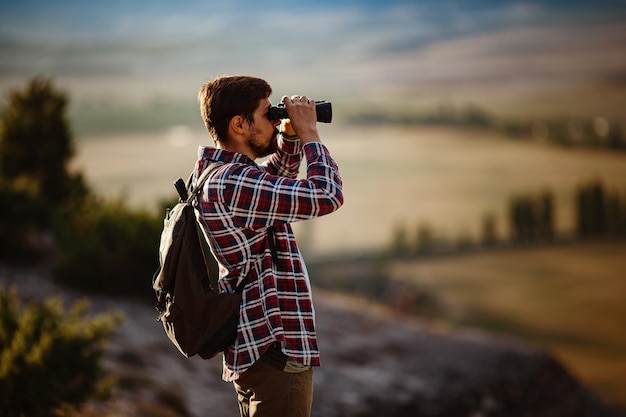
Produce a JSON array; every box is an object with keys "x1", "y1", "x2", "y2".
[{"x1": 194, "y1": 138, "x2": 343, "y2": 381}]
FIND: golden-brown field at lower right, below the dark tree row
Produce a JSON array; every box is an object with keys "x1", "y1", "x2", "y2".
[{"x1": 391, "y1": 242, "x2": 626, "y2": 405}]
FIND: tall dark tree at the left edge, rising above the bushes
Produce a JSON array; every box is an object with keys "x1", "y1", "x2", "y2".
[{"x1": 0, "y1": 77, "x2": 88, "y2": 260}]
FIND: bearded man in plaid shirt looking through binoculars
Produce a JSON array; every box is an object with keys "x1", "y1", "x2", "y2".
[{"x1": 195, "y1": 76, "x2": 343, "y2": 417}]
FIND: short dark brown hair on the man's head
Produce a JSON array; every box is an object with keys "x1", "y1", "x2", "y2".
[{"x1": 198, "y1": 75, "x2": 272, "y2": 142}]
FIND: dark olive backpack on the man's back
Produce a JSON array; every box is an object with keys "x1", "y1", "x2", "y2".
[{"x1": 152, "y1": 162, "x2": 243, "y2": 359}]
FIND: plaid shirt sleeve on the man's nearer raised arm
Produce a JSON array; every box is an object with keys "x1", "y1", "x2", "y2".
[{"x1": 215, "y1": 142, "x2": 343, "y2": 229}]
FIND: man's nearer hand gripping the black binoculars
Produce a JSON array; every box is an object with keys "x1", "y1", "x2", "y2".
[{"x1": 282, "y1": 96, "x2": 320, "y2": 145}]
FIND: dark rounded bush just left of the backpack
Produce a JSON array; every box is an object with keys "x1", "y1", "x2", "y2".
[{"x1": 54, "y1": 201, "x2": 162, "y2": 296}]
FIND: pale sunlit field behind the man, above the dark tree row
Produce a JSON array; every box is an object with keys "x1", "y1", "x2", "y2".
[{"x1": 75, "y1": 125, "x2": 626, "y2": 253}]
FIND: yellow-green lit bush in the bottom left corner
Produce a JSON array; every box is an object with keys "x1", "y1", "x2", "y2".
[{"x1": 0, "y1": 288, "x2": 121, "y2": 417}]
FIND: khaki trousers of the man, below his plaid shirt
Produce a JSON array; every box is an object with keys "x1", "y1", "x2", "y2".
[{"x1": 233, "y1": 360, "x2": 313, "y2": 417}]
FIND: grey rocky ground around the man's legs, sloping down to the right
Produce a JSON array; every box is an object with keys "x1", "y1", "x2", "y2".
[{"x1": 0, "y1": 267, "x2": 623, "y2": 417}]
